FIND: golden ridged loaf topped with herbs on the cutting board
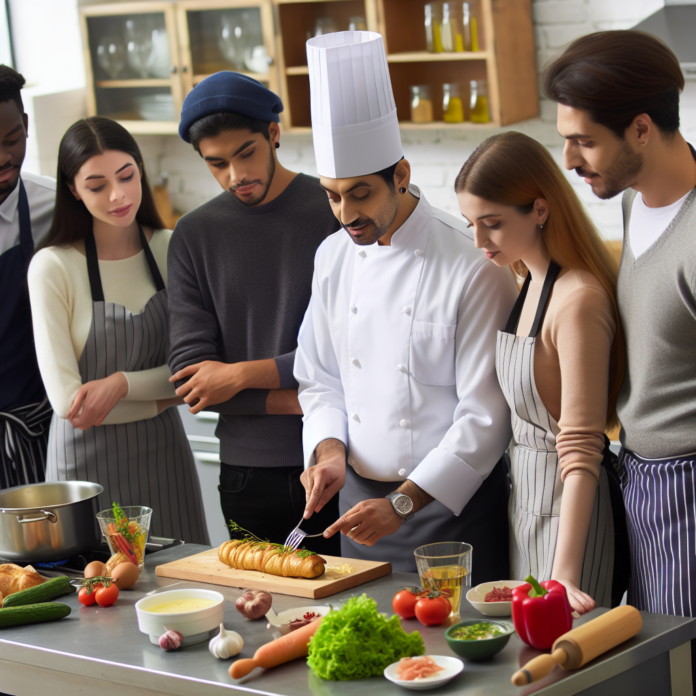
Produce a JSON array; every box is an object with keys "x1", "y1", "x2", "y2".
[{"x1": 218, "y1": 539, "x2": 326, "y2": 578}]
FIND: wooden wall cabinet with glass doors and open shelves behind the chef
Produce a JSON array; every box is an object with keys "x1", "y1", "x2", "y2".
[{"x1": 80, "y1": 0, "x2": 538, "y2": 134}]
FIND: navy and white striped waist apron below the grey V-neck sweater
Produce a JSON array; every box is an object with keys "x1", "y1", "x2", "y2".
[{"x1": 619, "y1": 449, "x2": 696, "y2": 616}]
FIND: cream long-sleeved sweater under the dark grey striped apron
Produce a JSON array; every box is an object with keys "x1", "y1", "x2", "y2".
[{"x1": 28, "y1": 230, "x2": 176, "y2": 424}]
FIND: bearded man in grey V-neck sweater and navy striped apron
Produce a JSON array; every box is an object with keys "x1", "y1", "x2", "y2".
[{"x1": 543, "y1": 31, "x2": 696, "y2": 681}]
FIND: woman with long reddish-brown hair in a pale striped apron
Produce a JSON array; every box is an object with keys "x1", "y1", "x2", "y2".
[{"x1": 455, "y1": 132, "x2": 628, "y2": 613}]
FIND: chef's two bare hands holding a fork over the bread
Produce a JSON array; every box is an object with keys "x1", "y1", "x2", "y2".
[{"x1": 300, "y1": 440, "x2": 433, "y2": 546}]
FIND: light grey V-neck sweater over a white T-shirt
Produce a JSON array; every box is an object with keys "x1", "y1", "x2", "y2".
[{"x1": 617, "y1": 189, "x2": 696, "y2": 459}]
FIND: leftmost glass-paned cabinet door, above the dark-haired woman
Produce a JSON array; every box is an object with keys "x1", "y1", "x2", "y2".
[{"x1": 81, "y1": 2, "x2": 182, "y2": 132}]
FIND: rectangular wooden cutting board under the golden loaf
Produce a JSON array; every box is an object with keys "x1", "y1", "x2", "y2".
[{"x1": 155, "y1": 548, "x2": 391, "y2": 599}]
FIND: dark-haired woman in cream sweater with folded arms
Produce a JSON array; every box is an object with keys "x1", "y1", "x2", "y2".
[{"x1": 28, "y1": 117, "x2": 208, "y2": 543}]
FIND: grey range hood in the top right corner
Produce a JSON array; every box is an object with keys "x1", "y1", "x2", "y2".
[{"x1": 633, "y1": 0, "x2": 696, "y2": 80}]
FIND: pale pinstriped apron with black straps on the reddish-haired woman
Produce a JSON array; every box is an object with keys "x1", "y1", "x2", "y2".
[{"x1": 496, "y1": 262, "x2": 616, "y2": 607}]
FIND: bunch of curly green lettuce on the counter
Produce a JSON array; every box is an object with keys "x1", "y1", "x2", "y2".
[{"x1": 307, "y1": 594, "x2": 425, "y2": 681}]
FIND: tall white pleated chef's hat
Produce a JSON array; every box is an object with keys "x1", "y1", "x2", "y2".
[{"x1": 307, "y1": 31, "x2": 404, "y2": 179}]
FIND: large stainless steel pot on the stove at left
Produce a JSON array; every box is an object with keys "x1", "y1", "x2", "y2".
[{"x1": 0, "y1": 481, "x2": 104, "y2": 563}]
